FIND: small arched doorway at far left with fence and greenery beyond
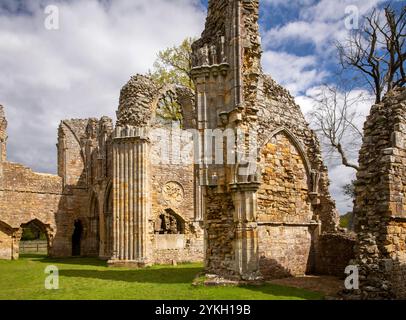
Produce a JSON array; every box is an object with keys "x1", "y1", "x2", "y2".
[{"x1": 19, "y1": 219, "x2": 49, "y2": 255}]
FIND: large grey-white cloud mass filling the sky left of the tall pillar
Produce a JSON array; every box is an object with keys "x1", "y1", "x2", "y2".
[{"x1": 0, "y1": 0, "x2": 205, "y2": 172}]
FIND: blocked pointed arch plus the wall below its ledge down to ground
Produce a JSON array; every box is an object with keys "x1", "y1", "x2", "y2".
[{"x1": 258, "y1": 130, "x2": 313, "y2": 278}]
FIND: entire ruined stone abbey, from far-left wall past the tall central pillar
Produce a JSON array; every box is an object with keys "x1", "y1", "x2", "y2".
[{"x1": 0, "y1": 0, "x2": 405, "y2": 286}]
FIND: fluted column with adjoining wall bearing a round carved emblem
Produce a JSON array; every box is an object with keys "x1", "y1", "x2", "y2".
[{"x1": 109, "y1": 75, "x2": 204, "y2": 266}]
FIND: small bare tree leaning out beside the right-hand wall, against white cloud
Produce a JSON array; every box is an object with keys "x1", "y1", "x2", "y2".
[{"x1": 309, "y1": 85, "x2": 364, "y2": 170}]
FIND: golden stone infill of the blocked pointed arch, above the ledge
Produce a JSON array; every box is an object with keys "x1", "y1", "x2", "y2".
[{"x1": 258, "y1": 131, "x2": 312, "y2": 222}]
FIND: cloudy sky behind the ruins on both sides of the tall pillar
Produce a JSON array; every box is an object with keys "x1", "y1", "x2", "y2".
[{"x1": 0, "y1": 0, "x2": 405, "y2": 213}]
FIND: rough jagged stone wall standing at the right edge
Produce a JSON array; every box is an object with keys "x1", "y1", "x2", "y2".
[{"x1": 351, "y1": 88, "x2": 406, "y2": 299}]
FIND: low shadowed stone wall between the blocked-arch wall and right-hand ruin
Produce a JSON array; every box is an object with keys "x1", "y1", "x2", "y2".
[{"x1": 316, "y1": 232, "x2": 356, "y2": 278}]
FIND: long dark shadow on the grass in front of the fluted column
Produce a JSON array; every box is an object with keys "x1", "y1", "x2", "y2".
[{"x1": 59, "y1": 267, "x2": 202, "y2": 284}]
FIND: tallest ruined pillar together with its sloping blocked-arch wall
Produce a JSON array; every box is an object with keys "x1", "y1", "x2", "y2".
[{"x1": 192, "y1": 0, "x2": 338, "y2": 279}]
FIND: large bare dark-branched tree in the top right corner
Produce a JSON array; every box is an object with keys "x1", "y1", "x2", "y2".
[{"x1": 337, "y1": 6, "x2": 406, "y2": 103}]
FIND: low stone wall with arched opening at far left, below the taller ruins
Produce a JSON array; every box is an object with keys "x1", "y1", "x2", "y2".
[{"x1": 0, "y1": 161, "x2": 62, "y2": 259}]
